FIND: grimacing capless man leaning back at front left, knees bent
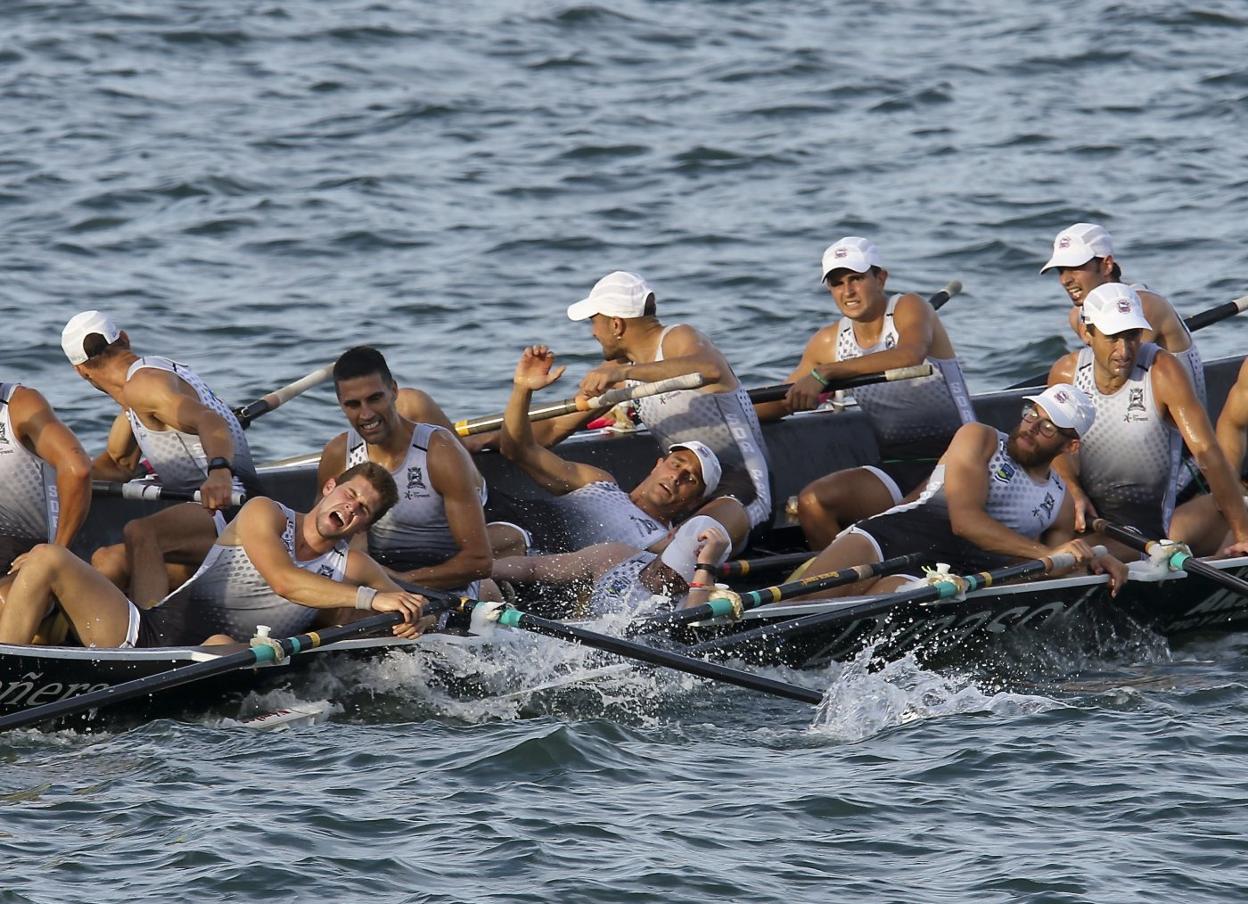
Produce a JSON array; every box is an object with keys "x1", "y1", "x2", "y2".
[{"x1": 0, "y1": 462, "x2": 426, "y2": 647}]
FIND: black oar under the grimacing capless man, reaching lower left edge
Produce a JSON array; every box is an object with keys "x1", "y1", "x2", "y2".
[{"x1": 0, "y1": 599, "x2": 457, "y2": 730}]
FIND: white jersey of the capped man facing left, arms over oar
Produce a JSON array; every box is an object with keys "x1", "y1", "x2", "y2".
[{"x1": 629, "y1": 323, "x2": 771, "y2": 527}]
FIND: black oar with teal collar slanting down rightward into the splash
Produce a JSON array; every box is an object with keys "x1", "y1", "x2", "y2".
[{"x1": 463, "y1": 599, "x2": 824, "y2": 704}]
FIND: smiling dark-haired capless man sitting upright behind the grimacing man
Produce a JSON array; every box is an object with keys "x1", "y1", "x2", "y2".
[{"x1": 317, "y1": 346, "x2": 493, "y2": 597}]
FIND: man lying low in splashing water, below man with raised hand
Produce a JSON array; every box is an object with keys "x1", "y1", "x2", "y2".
[{"x1": 494, "y1": 514, "x2": 731, "y2": 616}]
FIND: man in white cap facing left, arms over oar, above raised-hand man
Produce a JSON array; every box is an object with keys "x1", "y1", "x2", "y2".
[{"x1": 568, "y1": 270, "x2": 771, "y2": 547}]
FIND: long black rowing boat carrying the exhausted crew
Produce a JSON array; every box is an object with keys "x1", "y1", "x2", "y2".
[{"x1": 9, "y1": 358, "x2": 1248, "y2": 713}]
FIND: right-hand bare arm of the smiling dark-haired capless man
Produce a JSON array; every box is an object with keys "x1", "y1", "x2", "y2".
[{"x1": 393, "y1": 431, "x2": 493, "y2": 589}]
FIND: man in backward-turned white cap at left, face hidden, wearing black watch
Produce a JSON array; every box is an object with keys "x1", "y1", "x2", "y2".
[{"x1": 61, "y1": 311, "x2": 258, "y2": 606}]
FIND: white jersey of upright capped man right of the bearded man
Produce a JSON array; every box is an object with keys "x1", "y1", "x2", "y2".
[{"x1": 1075, "y1": 342, "x2": 1183, "y2": 537}]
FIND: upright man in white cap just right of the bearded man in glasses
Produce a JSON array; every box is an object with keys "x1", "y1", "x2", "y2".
[{"x1": 1048, "y1": 282, "x2": 1248, "y2": 557}]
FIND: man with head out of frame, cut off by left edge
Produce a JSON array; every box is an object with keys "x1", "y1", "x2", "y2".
[{"x1": 0, "y1": 383, "x2": 91, "y2": 602}]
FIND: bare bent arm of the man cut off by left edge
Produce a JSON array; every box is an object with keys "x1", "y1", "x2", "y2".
[{"x1": 9, "y1": 387, "x2": 91, "y2": 546}]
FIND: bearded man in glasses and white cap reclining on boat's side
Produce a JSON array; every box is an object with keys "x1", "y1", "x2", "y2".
[{"x1": 783, "y1": 383, "x2": 1127, "y2": 599}]
